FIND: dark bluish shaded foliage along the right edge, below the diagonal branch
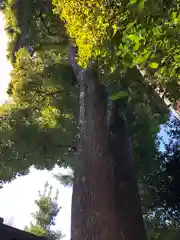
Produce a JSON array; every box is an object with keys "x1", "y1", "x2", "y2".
[{"x1": 144, "y1": 117, "x2": 180, "y2": 240}]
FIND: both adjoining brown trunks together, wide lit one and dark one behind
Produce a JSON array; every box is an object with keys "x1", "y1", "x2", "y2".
[{"x1": 70, "y1": 44, "x2": 147, "y2": 240}]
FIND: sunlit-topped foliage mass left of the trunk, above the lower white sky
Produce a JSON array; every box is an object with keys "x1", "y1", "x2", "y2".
[{"x1": 0, "y1": 49, "x2": 78, "y2": 177}]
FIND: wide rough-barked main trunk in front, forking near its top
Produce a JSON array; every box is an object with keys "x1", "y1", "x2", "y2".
[{"x1": 70, "y1": 48, "x2": 121, "y2": 240}]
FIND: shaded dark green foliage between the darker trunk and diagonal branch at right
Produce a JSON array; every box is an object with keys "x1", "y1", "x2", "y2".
[{"x1": 104, "y1": 68, "x2": 168, "y2": 180}]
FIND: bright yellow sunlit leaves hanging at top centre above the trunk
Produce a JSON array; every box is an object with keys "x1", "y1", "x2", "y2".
[{"x1": 53, "y1": 0, "x2": 114, "y2": 66}]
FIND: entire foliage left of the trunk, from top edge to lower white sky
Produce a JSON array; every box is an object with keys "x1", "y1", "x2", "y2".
[{"x1": 0, "y1": 0, "x2": 78, "y2": 181}]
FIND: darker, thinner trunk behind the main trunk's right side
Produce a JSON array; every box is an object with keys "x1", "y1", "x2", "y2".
[{"x1": 110, "y1": 101, "x2": 147, "y2": 240}]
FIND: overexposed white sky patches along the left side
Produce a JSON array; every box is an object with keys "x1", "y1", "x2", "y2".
[{"x1": 0, "y1": 13, "x2": 72, "y2": 240}]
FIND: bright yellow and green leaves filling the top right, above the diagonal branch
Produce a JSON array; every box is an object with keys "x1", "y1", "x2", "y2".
[{"x1": 53, "y1": 0, "x2": 180, "y2": 99}]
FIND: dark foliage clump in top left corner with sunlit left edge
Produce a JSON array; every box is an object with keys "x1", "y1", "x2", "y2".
[{"x1": 4, "y1": 0, "x2": 67, "y2": 63}]
